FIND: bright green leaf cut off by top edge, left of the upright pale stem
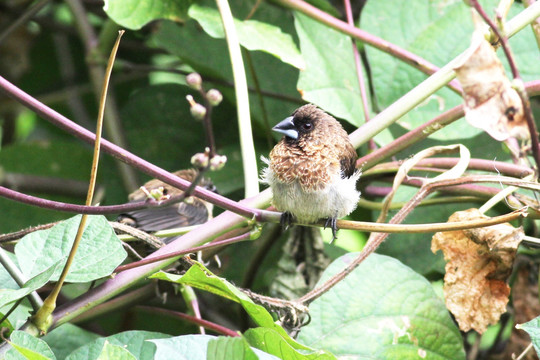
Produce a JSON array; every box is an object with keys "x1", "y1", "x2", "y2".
[{"x1": 103, "y1": 0, "x2": 192, "y2": 30}]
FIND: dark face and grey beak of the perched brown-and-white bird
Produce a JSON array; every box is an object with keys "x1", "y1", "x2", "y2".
[{"x1": 272, "y1": 104, "x2": 329, "y2": 140}]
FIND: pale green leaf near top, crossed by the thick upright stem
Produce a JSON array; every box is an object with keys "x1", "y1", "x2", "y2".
[{"x1": 188, "y1": 4, "x2": 305, "y2": 69}]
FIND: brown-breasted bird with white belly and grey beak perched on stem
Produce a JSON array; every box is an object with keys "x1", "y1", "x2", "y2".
[{"x1": 261, "y1": 104, "x2": 361, "y2": 240}]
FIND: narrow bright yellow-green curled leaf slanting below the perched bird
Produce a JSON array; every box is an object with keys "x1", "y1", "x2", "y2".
[{"x1": 150, "y1": 262, "x2": 309, "y2": 350}]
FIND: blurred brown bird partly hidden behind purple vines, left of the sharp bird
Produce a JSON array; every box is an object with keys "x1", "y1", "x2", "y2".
[{"x1": 118, "y1": 169, "x2": 216, "y2": 243}]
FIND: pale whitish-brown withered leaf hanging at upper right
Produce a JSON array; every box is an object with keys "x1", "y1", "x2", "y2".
[{"x1": 454, "y1": 33, "x2": 529, "y2": 141}]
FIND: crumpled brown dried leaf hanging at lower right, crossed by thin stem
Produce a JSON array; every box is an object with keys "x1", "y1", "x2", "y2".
[{"x1": 431, "y1": 209, "x2": 523, "y2": 333}]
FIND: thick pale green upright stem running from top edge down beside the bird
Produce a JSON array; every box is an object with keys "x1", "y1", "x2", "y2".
[{"x1": 216, "y1": 0, "x2": 259, "y2": 198}]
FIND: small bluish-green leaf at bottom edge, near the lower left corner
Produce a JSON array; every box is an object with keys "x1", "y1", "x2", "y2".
[{"x1": 43, "y1": 323, "x2": 99, "y2": 359}]
